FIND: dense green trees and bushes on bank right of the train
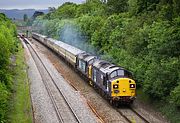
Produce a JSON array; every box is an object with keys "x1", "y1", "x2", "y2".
[{"x1": 33, "y1": 0, "x2": 180, "y2": 122}]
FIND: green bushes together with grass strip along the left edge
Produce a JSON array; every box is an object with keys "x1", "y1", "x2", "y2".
[{"x1": 0, "y1": 14, "x2": 31, "y2": 123}]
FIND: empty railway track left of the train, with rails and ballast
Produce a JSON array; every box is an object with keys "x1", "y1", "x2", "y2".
[{"x1": 22, "y1": 39, "x2": 81, "y2": 123}]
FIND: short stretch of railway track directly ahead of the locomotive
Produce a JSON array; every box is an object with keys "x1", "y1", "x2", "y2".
[{"x1": 116, "y1": 107, "x2": 150, "y2": 123}]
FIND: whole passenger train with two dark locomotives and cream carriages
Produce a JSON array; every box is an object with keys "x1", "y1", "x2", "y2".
[{"x1": 32, "y1": 33, "x2": 136, "y2": 106}]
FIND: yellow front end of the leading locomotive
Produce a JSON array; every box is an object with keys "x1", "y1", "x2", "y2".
[{"x1": 111, "y1": 78, "x2": 136, "y2": 101}]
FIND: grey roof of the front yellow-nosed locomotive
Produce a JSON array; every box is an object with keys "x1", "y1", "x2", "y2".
[{"x1": 93, "y1": 60, "x2": 124, "y2": 73}]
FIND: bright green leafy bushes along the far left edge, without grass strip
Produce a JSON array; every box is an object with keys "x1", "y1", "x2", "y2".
[{"x1": 0, "y1": 14, "x2": 16, "y2": 122}]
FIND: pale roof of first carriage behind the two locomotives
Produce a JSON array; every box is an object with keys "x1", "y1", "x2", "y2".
[{"x1": 55, "y1": 40, "x2": 84, "y2": 55}]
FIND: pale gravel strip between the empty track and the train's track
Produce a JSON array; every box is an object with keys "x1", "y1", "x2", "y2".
[{"x1": 30, "y1": 41, "x2": 98, "y2": 123}]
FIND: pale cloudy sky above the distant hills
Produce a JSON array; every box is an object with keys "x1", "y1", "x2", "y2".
[{"x1": 0, "y1": 0, "x2": 85, "y2": 9}]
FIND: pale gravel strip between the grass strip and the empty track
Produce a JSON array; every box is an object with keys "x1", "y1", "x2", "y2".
[{"x1": 23, "y1": 39, "x2": 58, "y2": 123}]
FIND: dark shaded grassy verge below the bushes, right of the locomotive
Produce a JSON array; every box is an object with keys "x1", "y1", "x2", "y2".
[{"x1": 137, "y1": 89, "x2": 180, "y2": 123}]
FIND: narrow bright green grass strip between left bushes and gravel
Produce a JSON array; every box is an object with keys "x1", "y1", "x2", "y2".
[{"x1": 9, "y1": 44, "x2": 32, "y2": 123}]
